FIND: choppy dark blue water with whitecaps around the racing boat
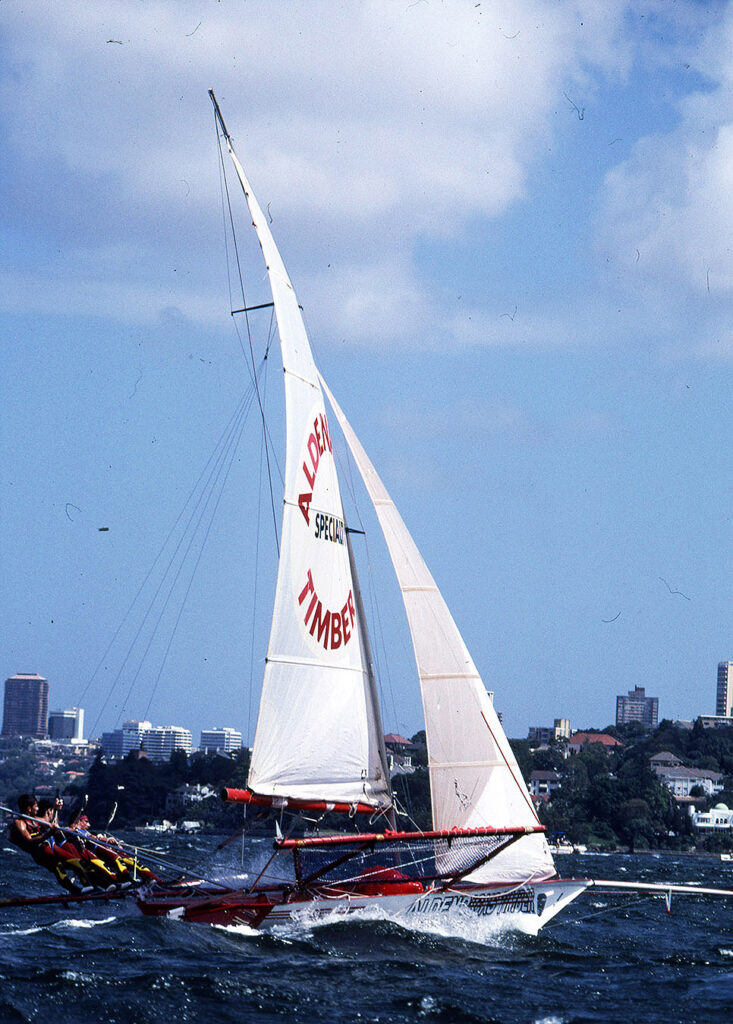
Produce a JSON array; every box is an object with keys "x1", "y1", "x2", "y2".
[{"x1": 0, "y1": 837, "x2": 733, "y2": 1024}]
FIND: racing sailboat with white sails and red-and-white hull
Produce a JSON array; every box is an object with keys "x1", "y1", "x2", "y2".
[{"x1": 138, "y1": 92, "x2": 590, "y2": 933}]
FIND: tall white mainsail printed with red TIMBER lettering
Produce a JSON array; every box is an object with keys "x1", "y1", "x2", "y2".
[{"x1": 222, "y1": 138, "x2": 391, "y2": 807}]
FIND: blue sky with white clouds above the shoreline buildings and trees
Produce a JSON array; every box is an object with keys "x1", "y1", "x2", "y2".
[{"x1": 0, "y1": 0, "x2": 733, "y2": 738}]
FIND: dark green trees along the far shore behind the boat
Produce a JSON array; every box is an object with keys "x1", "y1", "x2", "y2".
[{"x1": 5, "y1": 721, "x2": 733, "y2": 850}]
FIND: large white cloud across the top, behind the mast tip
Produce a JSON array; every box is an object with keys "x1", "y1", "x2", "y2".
[{"x1": 3, "y1": 0, "x2": 622, "y2": 220}]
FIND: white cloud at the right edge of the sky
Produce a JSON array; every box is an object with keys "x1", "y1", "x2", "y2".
[{"x1": 602, "y1": 7, "x2": 733, "y2": 302}]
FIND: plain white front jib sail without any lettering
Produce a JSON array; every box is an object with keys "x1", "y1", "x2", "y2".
[{"x1": 320, "y1": 378, "x2": 555, "y2": 882}]
